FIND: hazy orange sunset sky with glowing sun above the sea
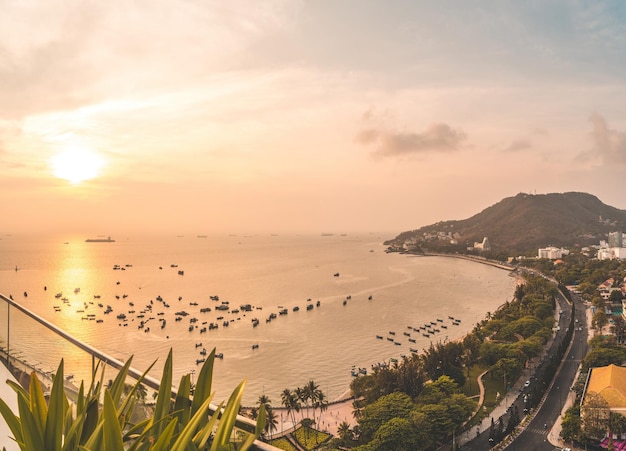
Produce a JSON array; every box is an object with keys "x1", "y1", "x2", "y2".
[{"x1": 0, "y1": 0, "x2": 626, "y2": 235}]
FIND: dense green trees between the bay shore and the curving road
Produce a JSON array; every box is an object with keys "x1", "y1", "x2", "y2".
[{"x1": 322, "y1": 274, "x2": 557, "y2": 451}]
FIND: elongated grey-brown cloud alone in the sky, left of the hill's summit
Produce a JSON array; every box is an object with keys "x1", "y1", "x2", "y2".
[{"x1": 356, "y1": 123, "x2": 466, "y2": 157}]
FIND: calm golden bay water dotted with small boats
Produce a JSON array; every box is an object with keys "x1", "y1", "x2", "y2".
[{"x1": 0, "y1": 235, "x2": 515, "y2": 405}]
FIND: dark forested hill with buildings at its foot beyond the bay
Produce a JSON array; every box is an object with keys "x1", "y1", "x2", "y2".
[{"x1": 385, "y1": 192, "x2": 626, "y2": 255}]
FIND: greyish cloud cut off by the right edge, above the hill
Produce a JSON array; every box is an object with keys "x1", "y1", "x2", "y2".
[{"x1": 581, "y1": 113, "x2": 626, "y2": 165}]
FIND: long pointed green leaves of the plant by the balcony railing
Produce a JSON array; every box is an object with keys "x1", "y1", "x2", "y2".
[{"x1": 0, "y1": 350, "x2": 265, "y2": 451}]
